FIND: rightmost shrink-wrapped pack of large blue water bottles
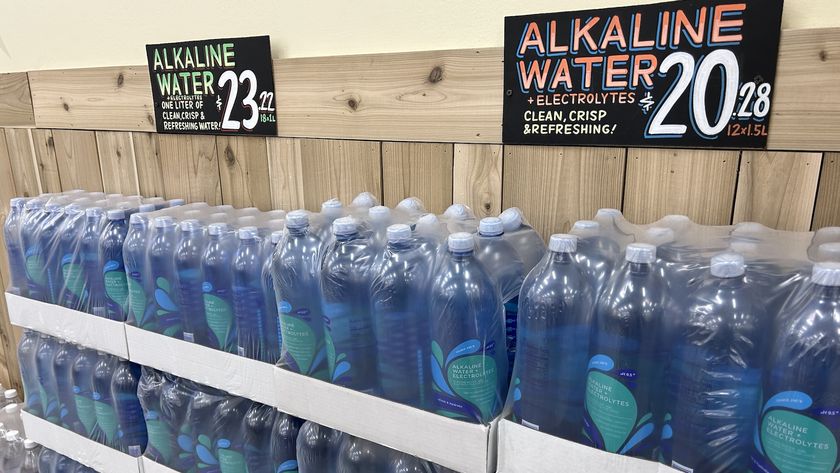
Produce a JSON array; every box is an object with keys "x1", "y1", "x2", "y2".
[{"x1": 508, "y1": 209, "x2": 840, "y2": 473}]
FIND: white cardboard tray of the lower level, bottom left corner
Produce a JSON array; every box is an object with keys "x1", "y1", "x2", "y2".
[{"x1": 21, "y1": 412, "x2": 143, "y2": 473}]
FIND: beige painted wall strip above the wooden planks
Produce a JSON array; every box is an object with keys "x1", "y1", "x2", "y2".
[{"x1": 0, "y1": 0, "x2": 840, "y2": 72}]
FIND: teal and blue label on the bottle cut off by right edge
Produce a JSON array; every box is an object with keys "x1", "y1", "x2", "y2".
[{"x1": 756, "y1": 391, "x2": 840, "y2": 473}]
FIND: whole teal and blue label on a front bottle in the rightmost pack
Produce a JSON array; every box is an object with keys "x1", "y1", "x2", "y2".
[{"x1": 584, "y1": 355, "x2": 655, "y2": 454}]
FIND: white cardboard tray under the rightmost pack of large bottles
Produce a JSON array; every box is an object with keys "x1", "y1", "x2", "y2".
[{"x1": 498, "y1": 420, "x2": 678, "y2": 473}]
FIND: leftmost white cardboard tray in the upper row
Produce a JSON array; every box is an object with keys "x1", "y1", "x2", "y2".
[{"x1": 6, "y1": 292, "x2": 129, "y2": 359}]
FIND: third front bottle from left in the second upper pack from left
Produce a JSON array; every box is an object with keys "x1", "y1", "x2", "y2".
[{"x1": 175, "y1": 219, "x2": 207, "y2": 345}]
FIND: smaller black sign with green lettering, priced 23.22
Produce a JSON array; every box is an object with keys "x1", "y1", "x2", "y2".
[{"x1": 146, "y1": 36, "x2": 277, "y2": 135}]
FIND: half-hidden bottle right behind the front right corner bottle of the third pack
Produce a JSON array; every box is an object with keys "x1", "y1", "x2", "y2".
[{"x1": 475, "y1": 217, "x2": 525, "y2": 373}]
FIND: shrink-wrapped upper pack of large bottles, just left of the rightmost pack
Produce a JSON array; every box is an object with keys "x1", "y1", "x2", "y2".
[{"x1": 272, "y1": 196, "x2": 544, "y2": 422}]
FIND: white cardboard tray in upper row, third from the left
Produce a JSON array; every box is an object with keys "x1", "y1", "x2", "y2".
[{"x1": 274, "y1": 368, "x2": 496, "y2": 473}]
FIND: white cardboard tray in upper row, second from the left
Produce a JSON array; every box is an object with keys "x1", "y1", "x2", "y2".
[{"x1": 125, "y1": 325, "x2": 277, "y2": 406}]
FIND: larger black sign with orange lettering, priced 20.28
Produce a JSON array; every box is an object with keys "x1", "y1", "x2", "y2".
[{"x1": 503, "y1": 0, "x2": 783, "y2": 148}]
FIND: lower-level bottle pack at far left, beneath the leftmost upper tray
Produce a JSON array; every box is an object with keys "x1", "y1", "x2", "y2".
[{"x1": 16, "y1": 329, "x2": 147, "y2": 456}]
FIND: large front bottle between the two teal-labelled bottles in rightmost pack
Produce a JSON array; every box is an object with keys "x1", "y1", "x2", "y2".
[{"x1": 662, "y1": 253, "x2": 767, "y2": 472}]
